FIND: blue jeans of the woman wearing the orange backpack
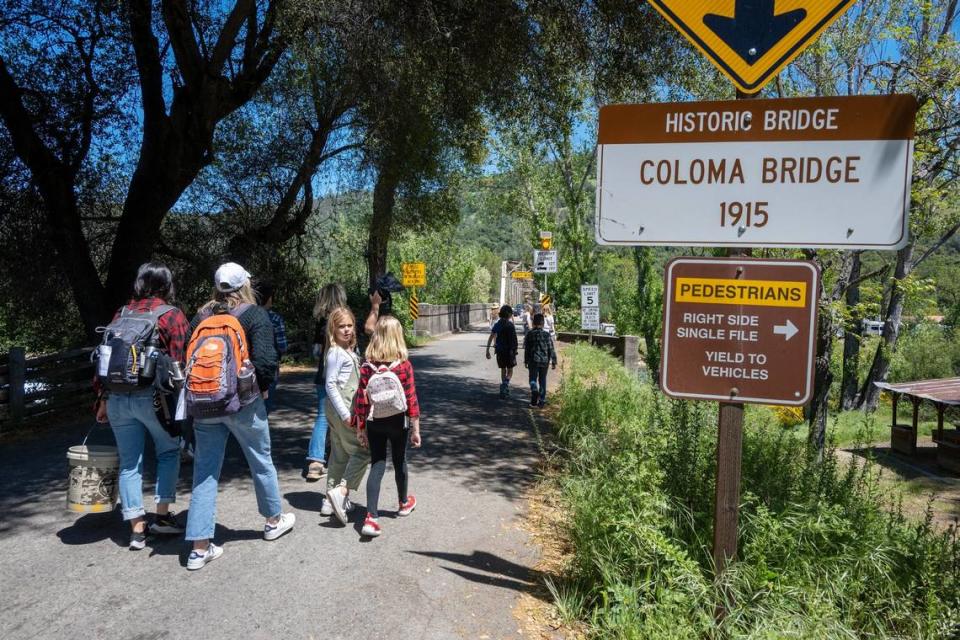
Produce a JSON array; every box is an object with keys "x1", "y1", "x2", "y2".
[{"x1": 185, "y1": 398, "x2": 283, "y2": 540}]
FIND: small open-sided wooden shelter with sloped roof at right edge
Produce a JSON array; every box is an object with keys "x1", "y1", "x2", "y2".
[{"x1": 874, "y1": 378, "x2": 960, "y2": 473}]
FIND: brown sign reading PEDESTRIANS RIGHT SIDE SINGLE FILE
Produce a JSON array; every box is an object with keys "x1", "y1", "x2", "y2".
[{"x1": 660, "y1": 258, "x2": 820, "y2": 405}]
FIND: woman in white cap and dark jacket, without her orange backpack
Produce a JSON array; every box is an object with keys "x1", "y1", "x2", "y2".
[{"x1": 186, "y1": 262, "x2": 296, "y2": 570}]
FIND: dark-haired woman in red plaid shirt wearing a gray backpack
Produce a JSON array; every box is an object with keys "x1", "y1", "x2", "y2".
[{"x1": 94, "y1": 262, "x2": 189, "y2": 550}]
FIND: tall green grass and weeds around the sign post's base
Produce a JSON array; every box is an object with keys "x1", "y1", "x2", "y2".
[{"x1": 552, "y1": 345, "x2": 960, "y2": 638}]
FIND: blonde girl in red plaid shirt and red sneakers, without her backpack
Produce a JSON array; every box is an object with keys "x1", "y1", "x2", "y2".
[{"x1": 353, "y1": 316, "x2": 420, "y2": 537}]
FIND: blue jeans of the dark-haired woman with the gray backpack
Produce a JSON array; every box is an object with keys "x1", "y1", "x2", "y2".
[{"x1": 107, "y1": 389, "x2": 180, "y2": 520}]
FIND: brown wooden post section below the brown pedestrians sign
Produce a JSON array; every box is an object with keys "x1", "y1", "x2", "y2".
[{"x1": 713, "y1": 402, "x2": 743, "y2": 577}]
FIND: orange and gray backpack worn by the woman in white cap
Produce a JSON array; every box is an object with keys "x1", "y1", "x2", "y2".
[{"x1": 185, "y1": 304, "x2": 259, "y2": 418}]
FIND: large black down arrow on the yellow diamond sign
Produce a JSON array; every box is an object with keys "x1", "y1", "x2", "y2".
[{"x1": 703, "y1": 0, "x2": 807, "y2": 64}]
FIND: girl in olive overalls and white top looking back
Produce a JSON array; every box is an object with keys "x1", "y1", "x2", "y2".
[{"x1": 320, "y1": 307, "x2": 370, "y2": 524}]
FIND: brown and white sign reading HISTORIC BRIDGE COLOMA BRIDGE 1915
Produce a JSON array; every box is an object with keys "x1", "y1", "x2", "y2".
[{"x1": 596, "y1": 95, "x2": 917, "y2": 249}]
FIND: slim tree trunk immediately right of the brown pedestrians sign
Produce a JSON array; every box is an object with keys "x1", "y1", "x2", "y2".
[{"x1": 807, "y1": 251, "x2": 856, "y2": 458}]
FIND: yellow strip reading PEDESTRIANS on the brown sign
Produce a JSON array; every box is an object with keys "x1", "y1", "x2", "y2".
[{"x1": 674, "y1": 278, "x2": 807, "y2": 307}]
